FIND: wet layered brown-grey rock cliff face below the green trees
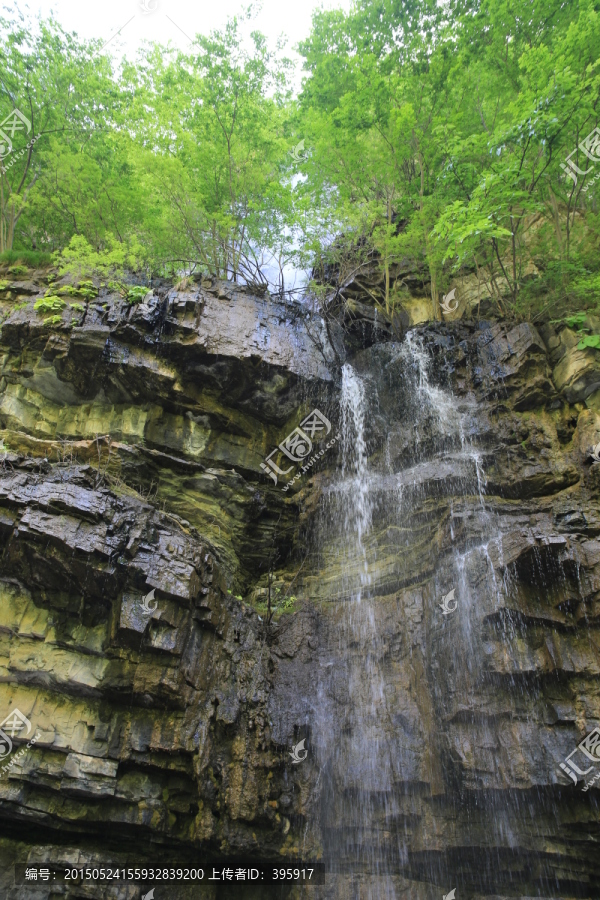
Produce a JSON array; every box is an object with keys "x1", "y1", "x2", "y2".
[{"x1": 0, "y1": 276, "x2": 600, "y2": 900}]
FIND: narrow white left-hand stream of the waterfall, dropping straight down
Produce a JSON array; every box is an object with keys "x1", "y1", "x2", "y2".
[{"x1": 314, "y1": 365, "x2": 395, "y2": 900}]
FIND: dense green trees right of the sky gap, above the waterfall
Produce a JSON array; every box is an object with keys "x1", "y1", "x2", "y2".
[{"x1": 297, "y1": 0, "x2": 600, "y2": 317}]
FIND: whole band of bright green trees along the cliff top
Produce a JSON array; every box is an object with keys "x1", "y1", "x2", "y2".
[{"x1": 0, "y1": 0, "x2": 600, "y2": 316}]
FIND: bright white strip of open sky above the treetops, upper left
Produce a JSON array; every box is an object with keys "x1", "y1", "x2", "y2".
[{"x1": 9, "y1": 0, "x2": 351, "y2": 89}]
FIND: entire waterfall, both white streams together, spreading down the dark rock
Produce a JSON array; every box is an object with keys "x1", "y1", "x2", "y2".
[{"x1": 312, "y1": 335, "x2": 580, "y2": 900}]
